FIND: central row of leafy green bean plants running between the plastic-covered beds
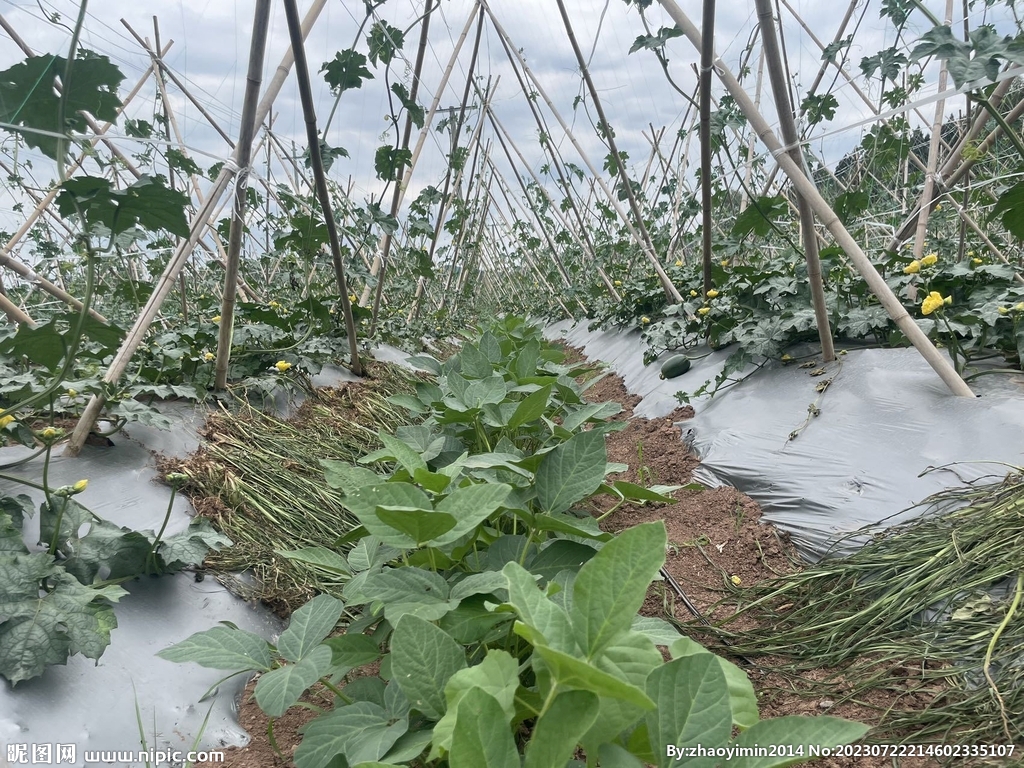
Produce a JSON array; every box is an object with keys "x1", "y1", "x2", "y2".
[{"x1": 160, "y1": 318, "x2": 867, "y2": 768}]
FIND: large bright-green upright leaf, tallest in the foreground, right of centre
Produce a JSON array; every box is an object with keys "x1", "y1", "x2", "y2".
[{"x1": 571, "y1": 524, "x2": 667, "y2": 658}]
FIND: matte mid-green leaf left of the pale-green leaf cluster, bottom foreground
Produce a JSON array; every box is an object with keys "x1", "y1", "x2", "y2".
[{"x1": 391, "y1": 614, "x2": 466, "y2": 720}]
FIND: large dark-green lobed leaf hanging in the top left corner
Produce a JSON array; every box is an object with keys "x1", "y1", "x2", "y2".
[{"x1": 0, "y1": 49, "x2": 124, "y2": 160}]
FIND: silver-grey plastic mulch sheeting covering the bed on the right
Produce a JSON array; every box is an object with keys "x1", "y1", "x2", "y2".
[{"x1": 548, "y1": 324, "x2": 1024, "y2": 559}]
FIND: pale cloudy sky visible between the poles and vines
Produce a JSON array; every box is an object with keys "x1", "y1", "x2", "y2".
[{"x1": 0, "y1": 0, "x2": 1011, "y2": 240}]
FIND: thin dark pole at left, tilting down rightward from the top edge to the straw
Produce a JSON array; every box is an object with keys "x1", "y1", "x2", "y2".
[{"x1": 285, "y1": 0, "x2": 362, "y2": 376}]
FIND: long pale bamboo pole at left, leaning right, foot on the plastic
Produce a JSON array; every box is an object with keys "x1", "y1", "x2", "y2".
[{"x1": 65, "y1": 0, "x2": 327, "y2": 457}]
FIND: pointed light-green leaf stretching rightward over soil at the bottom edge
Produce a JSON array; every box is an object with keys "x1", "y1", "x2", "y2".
[{"x1": 729, "y1": 715, "x2": 870, "y2": 768}]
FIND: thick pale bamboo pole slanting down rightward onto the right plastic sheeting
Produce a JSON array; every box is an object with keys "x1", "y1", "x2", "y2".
[{"x1": 658, "y1": 0, "x2": 974, "y2": 397}]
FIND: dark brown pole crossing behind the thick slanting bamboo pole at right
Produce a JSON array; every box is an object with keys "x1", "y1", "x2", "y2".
[{"x1": 753, "y1": 0, "x2": 831, "y2": 362}]
